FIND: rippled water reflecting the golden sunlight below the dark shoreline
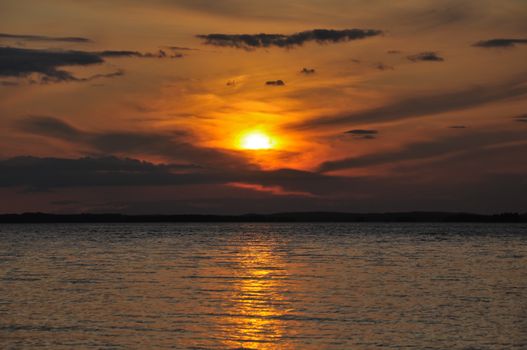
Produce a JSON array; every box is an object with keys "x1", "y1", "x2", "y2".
[{"x1": 0, "y1": 224, "x2": 527, "y2": 350}]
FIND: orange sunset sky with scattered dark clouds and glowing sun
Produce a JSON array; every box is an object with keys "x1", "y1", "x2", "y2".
[{"x1": 0, "y1": 0, "x2": 527, "y2": 214}]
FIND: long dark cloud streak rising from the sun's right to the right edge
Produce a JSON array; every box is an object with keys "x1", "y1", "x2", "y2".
[{"x1": 290, "y1": 74, "x2": 527, "y2": 129}]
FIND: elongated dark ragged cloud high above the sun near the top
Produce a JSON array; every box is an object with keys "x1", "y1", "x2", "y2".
[{"x1": 198, "y1": 29, "x2": 382, "y2": 49}]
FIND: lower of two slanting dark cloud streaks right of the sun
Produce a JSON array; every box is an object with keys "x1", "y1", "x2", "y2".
[{"x1": 319, "y1": 131, "x2": 525, "y2": 172}]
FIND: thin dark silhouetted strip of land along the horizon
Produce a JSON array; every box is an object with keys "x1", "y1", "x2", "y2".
[{"x1": 0, "y1": 212, "x2": 527, "y2": 223}]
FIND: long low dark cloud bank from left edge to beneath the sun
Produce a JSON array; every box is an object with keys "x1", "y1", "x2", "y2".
[{"x1": 0, "y1": 156, "x2": 359, "y2": 194}]
